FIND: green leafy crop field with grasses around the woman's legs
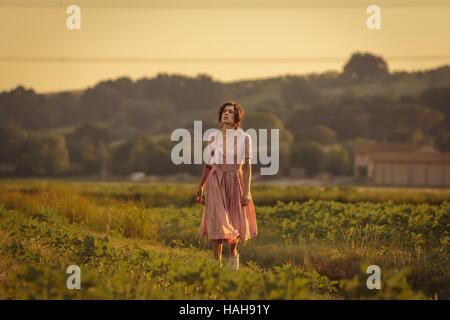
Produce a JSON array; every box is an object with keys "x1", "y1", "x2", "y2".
[{"x1": 0, "y1": 180, "x2": 450, "y2": 299}]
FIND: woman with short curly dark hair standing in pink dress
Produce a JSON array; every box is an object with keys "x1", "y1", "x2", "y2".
[{"x1": 196, "y1": 102, "x2": 257, "y2": 270}]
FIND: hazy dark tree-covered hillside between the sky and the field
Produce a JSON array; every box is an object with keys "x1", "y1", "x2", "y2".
[{"x1": 0, "y1": 53, "x2": 450, "y2": 177}]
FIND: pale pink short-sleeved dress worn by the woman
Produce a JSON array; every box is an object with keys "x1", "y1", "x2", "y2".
[{"x1": 200, "y1": 128, "x2": 258, "y2": 243}]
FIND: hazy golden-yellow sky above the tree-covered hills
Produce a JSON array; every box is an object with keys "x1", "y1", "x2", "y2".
[{"x1": 0, "y1": 0, "x2": 450, "y2": 93}]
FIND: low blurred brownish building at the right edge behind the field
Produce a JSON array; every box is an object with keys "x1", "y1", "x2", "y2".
[{"x1": 354, "y1": 143, "x2": 450, "y2": 188}]
